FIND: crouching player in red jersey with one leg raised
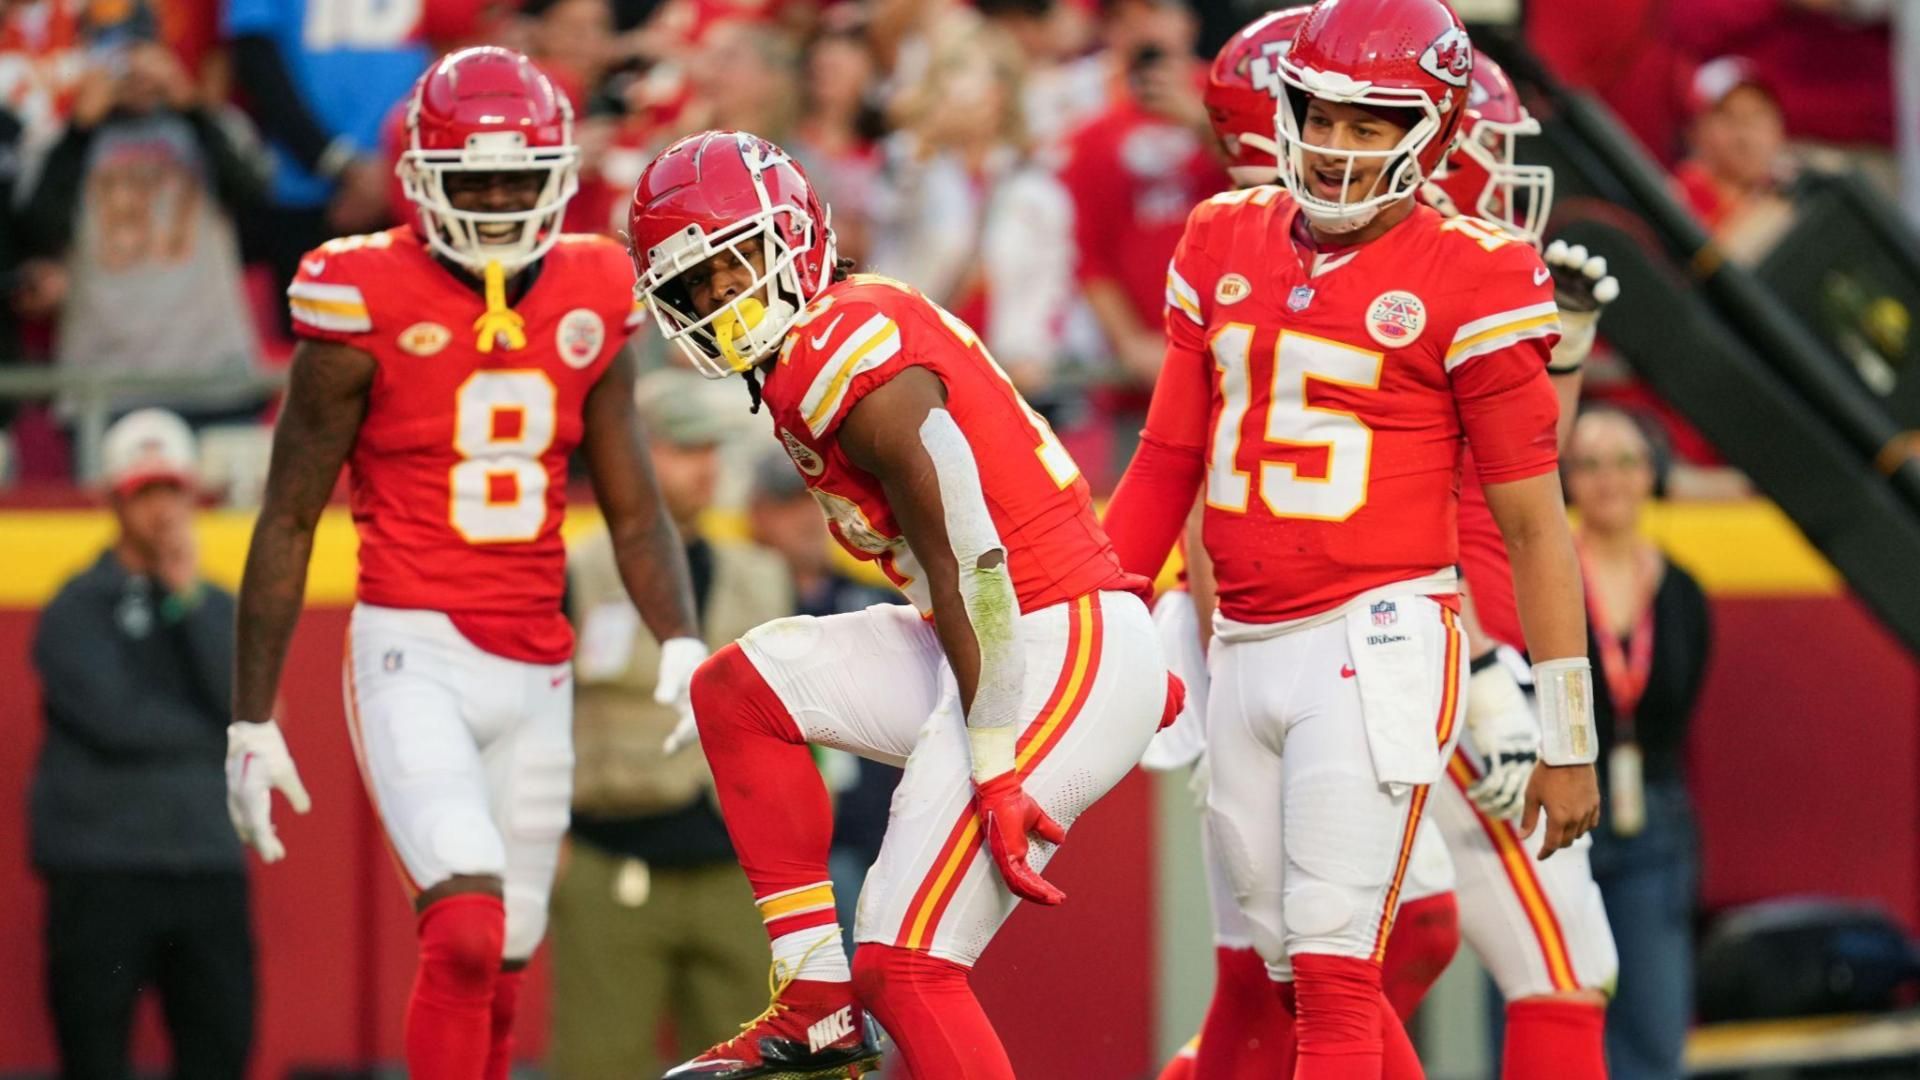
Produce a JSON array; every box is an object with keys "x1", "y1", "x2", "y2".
[{"x1": 630, "y1": 133, "x2": 1177, "y2": 1080}]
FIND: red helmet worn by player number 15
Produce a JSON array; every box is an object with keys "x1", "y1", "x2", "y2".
[{"x1": 1277, "y1": 0, "x2": 1473, "y2": 233}]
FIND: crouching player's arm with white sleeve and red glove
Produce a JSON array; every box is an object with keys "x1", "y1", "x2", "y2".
[{"x1": 837, "y1": 367, "x2": 1066, "y2": 903}]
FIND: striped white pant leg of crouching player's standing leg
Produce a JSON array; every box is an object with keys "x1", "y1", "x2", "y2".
[{"x1": 854, "y1": 592, "x2": 1165, "y2": 967}]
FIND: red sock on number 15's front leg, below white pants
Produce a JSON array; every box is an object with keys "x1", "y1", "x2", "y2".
[{"x1": 1290, "y1": 953, "x2": 1423, "y2": 1080}]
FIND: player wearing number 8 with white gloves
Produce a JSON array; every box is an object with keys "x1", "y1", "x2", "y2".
[{"x1": 227, "y1": 48, "x2": 707, "y2": 1080}]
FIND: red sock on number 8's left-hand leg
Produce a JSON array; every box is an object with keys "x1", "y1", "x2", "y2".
[{"x1": 407, "y1": 894, "x2": 507, "y2": 1080}]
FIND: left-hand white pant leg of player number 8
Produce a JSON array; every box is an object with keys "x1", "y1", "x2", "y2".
[{"x1": 346, "y1": 603, "x2": 524, "y2": 892}]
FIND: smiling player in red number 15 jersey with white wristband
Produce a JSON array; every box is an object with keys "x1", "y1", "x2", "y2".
[{"x1": 1108, "y1": 0, "x2": 1597, "y2": 1078}]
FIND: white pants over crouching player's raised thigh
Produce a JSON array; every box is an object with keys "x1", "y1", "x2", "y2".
[{"x1": 739, "y1": 603, "x2": 950, "y2": 765}]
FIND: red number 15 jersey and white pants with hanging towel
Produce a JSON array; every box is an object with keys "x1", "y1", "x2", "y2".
[{"x1": 1108, "y1": 186, "x2": 1557, "y2": 967}]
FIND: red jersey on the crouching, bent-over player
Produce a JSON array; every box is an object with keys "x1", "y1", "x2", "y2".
[{"x1": 766, "y1": 275, "x2": 1148, "y2": 613}]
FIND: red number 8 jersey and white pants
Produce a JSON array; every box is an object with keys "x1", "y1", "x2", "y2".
[{"x1": 288, "y1": 227, "x2": 634, "y2": 957}]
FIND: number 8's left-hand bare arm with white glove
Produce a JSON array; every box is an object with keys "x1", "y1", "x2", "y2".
[{"x1": 227, "y1": 340, "x2": 374, "y2": 863}]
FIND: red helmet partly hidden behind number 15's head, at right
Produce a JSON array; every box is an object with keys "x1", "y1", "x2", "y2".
[{"x1": 1421, "y1": 56, "x2": 1553, "y2": 248}]
